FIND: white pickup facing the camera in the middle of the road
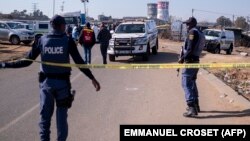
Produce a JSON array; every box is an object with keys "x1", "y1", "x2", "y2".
[{"x1": 107, "y1": 20, "x2": 158, "y2": 61}]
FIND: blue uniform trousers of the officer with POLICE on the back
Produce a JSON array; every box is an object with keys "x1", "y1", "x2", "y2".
[{"x1": 39, "y1": 78, "x2": 70, "y2": 141}]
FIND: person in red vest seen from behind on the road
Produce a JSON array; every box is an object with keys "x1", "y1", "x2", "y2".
[{"x1": 79, "y1": 23, "x2": 96, "y2": 64}]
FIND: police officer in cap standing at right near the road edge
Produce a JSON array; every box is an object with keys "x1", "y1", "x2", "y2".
[{"x1": 178, "y1": 17, "x2": 204, "y2": 117}]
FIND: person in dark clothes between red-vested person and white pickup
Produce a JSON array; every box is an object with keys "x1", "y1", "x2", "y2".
[{"x1": 97, "y1": 24, "x2": 111, "y2": 64}]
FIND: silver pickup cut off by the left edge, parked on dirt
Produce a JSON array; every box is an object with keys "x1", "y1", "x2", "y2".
[{"x1": 0, "y1": 21, "x2": 35, "y2": 45}]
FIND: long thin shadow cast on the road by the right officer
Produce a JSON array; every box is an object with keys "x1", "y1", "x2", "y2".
[{"x1": 196, "y1": 109, "x2": 250, "y2": 119}]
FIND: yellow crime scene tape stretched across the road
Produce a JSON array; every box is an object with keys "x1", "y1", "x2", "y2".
[{"x1": 22, "y1": 59, "x2": 250, "y2": 69}]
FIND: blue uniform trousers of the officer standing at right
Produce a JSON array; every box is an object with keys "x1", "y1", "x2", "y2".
[{"x1": 182, "y1": 68, "x2": 199, "y2": 105}]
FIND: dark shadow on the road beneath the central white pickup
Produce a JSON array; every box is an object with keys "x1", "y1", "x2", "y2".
[{"x1": 116, "y1": 52, "x2": 179, "y2": 64}]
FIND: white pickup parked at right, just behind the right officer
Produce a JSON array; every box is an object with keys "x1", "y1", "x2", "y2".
[{"x1": 203, "y1": 29, "x2": 235, "y2": 54}]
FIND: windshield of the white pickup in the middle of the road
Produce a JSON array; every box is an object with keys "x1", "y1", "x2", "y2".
[{"x1": 115, "y1": 24, "x2": 145, "y2": 33}]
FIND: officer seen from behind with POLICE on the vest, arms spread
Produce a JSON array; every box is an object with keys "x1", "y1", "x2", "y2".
[{"x1": 0, "y1": 15, "x2": 100, "y2": 141}]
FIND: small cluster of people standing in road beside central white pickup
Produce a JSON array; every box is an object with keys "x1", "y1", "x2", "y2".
[{"x1": 66, "y1": 22, "x2": 111, "y2": 64}]
